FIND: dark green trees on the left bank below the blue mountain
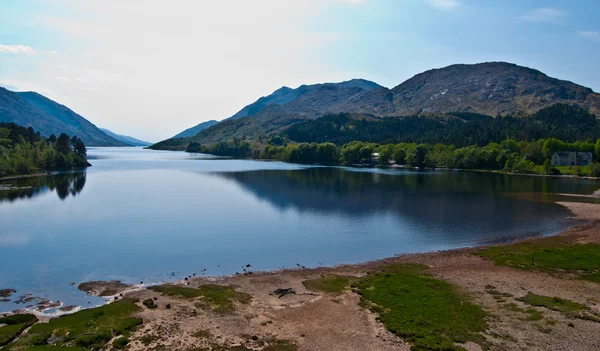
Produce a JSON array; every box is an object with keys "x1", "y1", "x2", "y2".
[{"x1": 0, "y1": 123, "x2": 89, "y2": 177}]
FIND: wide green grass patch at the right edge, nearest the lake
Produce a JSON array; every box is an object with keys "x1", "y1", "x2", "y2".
[{"x1": 477, "y1": 241, "x2": 600, "y2": 283}]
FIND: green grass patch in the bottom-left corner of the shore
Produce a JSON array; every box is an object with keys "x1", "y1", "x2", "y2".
[{"x1": 6, "y1": 299, "x2": 142, "y2": 350}]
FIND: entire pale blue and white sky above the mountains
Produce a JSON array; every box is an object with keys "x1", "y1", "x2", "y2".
[{"x1": 0, "y1": 0, "x2": 600, "y2": 142}]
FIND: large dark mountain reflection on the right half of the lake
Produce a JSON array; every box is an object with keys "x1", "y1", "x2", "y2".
[{"x1": 217, "y1": 168, "x2": 600, "y2": 240}]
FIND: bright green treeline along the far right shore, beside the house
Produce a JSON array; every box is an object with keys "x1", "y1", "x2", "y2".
[{"x1": 260, "y1": 138, "x2": 600, "y2": 176}]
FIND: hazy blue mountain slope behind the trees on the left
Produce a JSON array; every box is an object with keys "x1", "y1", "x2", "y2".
[{"x1": 0, "y1": 87, "x2": 130, "y2": 146}]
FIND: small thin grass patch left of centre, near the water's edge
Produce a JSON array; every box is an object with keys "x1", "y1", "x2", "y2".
[{"x1": 150, "y1": 284, "x2": 251, "y2": 313}]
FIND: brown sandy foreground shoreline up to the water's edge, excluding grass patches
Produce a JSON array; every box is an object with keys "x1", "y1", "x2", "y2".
[{"x1": 4, "y1": 202, "x2": 600, "y2": 351}]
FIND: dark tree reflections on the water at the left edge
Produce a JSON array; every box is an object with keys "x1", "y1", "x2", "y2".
[{"x1": 0, "y1": 172, "x2": 86, "y2": 203}]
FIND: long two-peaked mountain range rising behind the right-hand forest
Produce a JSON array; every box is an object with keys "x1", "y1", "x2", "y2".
[{"x1": 151, "y1": 62, "x2": 600, "y2": 149}]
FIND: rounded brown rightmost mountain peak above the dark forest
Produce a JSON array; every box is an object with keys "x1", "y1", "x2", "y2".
[{"x1": 392, "y1": 62, "x2": 600, "y2": 116}]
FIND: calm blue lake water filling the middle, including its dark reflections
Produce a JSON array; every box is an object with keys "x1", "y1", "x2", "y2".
[{"x1": 0, "y1": 148, "x2": 600, "y2": 311}]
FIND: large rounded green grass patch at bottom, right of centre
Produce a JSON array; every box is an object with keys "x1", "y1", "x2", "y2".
[{"x1": 353, "y1": 265, "x2": 487, "y2": 350}]
